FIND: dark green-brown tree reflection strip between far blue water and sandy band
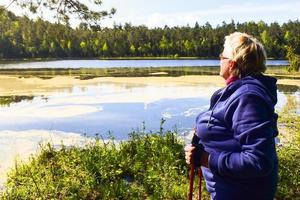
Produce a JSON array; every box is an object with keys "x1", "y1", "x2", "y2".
[{"x1": 0, "y1": 66, "x2": 219, "y2": 80}]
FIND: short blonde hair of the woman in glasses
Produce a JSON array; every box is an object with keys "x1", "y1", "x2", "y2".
[{"x1": 224, "y1": 32, "x2": 267, "y2": 77}]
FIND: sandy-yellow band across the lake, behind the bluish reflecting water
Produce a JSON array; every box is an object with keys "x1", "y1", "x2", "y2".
[{"x1": 0, "y1": 75, "x2": 300, "y2": 96}]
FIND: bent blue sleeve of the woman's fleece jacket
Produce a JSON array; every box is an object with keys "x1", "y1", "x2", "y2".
[{"x1": 209, "y1": 94, "x2": 276, "y2": 178}]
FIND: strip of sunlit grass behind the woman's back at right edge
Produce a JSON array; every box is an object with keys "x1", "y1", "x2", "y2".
[{"x1": 276, "y1": 93, "x2": 300, "y2": 200}]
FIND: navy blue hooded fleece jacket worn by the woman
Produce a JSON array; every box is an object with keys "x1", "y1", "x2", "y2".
[{"x1": 196, "y1": 75, "x2": 278, "y2": 200}]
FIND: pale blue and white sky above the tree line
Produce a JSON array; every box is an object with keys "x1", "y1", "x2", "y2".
[{"x1": 0, "y1": 0, "x2": 300, "y2": 28}]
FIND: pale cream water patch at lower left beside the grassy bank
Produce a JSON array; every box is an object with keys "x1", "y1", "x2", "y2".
[{"x1": 0, "y1": 130, "x2": 88, "y2": 185}]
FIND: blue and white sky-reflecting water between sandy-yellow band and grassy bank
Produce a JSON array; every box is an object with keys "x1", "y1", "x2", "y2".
[{"x1": 0, "y1": 82, "x2": 299, "y2": 139}]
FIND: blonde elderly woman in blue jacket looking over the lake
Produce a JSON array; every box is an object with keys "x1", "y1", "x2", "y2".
[{"x1": 185, "y1": 32, "x2": 278, "y2": 200}]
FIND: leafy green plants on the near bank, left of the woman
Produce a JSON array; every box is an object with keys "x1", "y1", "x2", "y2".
[{"x1": 2, "y1": 131, "x2": 195, "y2": 199}]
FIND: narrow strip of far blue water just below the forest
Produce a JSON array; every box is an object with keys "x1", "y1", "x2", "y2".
[{"x1": 0, "y1": 60, "x2": 288, "y2": 69}]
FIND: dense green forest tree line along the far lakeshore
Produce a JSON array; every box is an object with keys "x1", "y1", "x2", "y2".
[{"x1": 0, "y1": 8, "x2": 300, "y2": 59}]
